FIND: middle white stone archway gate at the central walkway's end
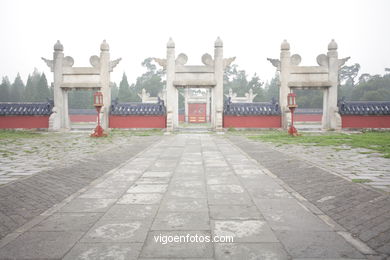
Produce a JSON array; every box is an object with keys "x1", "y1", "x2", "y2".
[{"x1": 155, "y1": 37, "x2": 235, "y2": 131}]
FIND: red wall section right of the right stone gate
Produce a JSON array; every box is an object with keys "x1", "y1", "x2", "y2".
[{"x1": 341, "y1": 115, "x2": 390, "y2": 128}]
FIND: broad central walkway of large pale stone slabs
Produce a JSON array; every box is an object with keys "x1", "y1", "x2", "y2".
[{"x1": 0, "y1": 134, "x2": 373, "y2": 259}]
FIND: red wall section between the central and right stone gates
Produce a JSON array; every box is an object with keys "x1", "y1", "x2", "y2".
[{"x1": 223, "y1": 115, "x2": 282, "y2": 128}]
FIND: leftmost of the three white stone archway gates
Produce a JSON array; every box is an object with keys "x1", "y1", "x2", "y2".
[{"x1": 42, "y1": 40, "x2": 121, "y2": 130}]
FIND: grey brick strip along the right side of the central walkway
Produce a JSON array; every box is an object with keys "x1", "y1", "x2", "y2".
[{"x1": 229, "y1": 136, "x2": 390, "y2": 256}]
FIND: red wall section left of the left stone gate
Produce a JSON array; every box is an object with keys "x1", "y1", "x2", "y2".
[{"x1": 0, "y1": 116, "x2": 49, "y2": 129}]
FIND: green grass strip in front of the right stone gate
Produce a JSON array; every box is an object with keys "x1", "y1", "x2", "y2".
[{"x1": 248, "y1": 131, "x2": 390, "y2": 158}]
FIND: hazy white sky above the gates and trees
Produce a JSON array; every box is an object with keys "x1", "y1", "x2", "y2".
[{"x1": 0, "y1": 0, "x2": 390, "y2": 85}]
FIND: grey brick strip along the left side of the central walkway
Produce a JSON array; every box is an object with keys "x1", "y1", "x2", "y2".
[{"x1": 0, "y1": 133, "x2": 159, "y2": 241}]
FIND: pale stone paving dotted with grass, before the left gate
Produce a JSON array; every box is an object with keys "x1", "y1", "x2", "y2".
[{"x1": 0, "y1": 131, "x2": 151, "y2": 185}]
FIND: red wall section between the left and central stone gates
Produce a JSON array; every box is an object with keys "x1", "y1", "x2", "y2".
[{"x1": 109, "y1": 115, "x2": 167, "y2": 128}]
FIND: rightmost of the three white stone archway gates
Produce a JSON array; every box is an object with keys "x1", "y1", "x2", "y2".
[{"x1": 268, "y1": 40, "x2": 349, "y2": 129}]
